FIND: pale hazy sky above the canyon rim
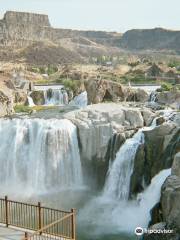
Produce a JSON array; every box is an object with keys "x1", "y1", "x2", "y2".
[{"x1": 0, "y1": 0, "x2": 180, "y2": 32}]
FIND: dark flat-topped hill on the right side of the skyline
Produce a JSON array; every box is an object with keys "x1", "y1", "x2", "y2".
[{"x1": 119, "y1": 28, "x2": 180, "y2": 51}]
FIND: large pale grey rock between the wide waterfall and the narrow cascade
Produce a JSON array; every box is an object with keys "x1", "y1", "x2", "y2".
[{"x1": 64, "y1": 103, "x2": 153, "y2": 187}]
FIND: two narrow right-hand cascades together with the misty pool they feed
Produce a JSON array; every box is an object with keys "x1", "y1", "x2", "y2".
[{"x1": 79, "y1": 119, "x2": 171, "y2": 235}]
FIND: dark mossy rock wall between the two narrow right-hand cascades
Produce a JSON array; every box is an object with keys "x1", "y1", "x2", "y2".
[{"x1": 130, "y1": 113, "x2": 180, "y2": 197}]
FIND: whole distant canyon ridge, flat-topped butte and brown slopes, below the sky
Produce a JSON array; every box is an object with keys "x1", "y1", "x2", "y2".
[{"x1": 0, "y1": 11, "x2": 180, "y2": 64}]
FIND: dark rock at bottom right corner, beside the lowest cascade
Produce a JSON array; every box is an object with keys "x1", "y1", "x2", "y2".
[{"x1": 144, "y1": 152, "x2": 180, "y2": 240}]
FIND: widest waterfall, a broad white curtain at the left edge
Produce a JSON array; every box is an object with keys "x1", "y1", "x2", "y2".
[{"x1": 0, "y1": 119, "x2": 82, "y2": 193}]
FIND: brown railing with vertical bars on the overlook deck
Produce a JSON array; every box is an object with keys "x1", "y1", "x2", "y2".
[{"x1": 0, "y1": 196, "x2": 76, "y2": 240}]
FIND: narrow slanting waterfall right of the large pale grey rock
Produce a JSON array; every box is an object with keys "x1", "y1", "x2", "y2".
[{"x1": 104, "y1": 130, "x2": 144, "y2": 200}]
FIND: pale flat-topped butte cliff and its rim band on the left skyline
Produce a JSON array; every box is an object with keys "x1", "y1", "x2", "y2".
[{"x1": 0, "y1": 11, "x2": 119, "y2": 45}]
